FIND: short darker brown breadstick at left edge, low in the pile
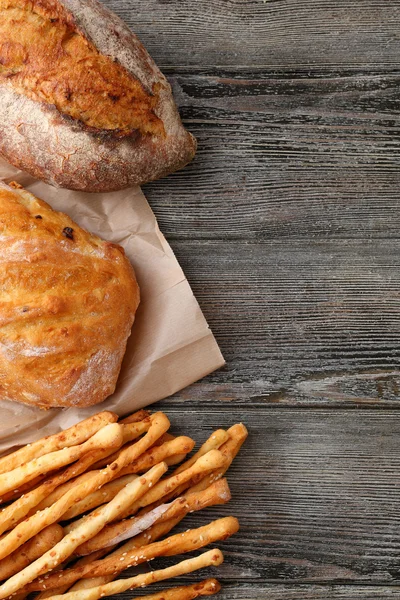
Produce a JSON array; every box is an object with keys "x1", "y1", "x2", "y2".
[{"x1": 0, "y1": 523, "x2": 64, "y2": 581}]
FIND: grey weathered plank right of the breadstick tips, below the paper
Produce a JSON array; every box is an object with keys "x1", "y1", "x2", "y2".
[{"x1": 111, "y1": 401, "x2": 400, "y2": 599}]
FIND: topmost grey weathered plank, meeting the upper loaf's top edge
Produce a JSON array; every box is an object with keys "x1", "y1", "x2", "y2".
[{"x1": 102, "y1": 0, "x2": 400, "y2": 68}]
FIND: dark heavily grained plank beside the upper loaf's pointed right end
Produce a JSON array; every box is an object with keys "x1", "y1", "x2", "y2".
[{"x1": 145, "y1": 71, "x2": 400, "y2": 240}]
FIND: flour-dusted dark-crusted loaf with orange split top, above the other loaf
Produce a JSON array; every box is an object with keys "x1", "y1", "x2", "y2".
[{"x1": 0, "y1": 0, "x2": 196, "y2": 192}]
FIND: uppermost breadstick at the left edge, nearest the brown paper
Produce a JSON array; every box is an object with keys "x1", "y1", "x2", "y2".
[{"x1": 0, "y1": 411, "x2": 118, "y2": 473}]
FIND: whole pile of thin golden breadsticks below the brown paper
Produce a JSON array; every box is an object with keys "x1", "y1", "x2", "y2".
[{"x1": 0, "y1": 411, "x2": 247, "y2": 600}]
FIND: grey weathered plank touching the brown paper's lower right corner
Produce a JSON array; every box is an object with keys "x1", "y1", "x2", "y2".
[{"x1": 154, "y1": 239, "x2": 400, "y2": 408}]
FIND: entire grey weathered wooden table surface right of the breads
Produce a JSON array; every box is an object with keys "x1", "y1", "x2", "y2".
[{"x1": 107, "y1": 0, "x2": 400, "y2": 600}]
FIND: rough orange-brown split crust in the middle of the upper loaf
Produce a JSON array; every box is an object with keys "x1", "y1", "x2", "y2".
[{"x1": 0, "y1": 0, "x2": 164, "y2": 135}]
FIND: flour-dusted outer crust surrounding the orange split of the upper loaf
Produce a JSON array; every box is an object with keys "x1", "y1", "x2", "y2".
[{"x1": 0, "y1": 0, "x2": 196, "y2": 192}]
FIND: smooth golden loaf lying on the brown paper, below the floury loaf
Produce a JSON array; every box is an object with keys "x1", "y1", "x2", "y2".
[{"x1": 0, "y1": 183, "x2": 139, "y2": 407}]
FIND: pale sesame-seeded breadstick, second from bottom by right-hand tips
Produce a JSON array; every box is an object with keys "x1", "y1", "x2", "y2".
[{"x1": 28, "y1": 550, "x2": 224, "y2": 600}]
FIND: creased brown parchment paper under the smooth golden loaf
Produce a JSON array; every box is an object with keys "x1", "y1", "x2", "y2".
[{"x1": 0, "y1": 159, "x2": 224, "y2": 451}]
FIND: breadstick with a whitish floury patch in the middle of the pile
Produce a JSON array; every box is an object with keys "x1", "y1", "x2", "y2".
[{"x1": 75, "y1": 479, "x2": 231, "y2": 555}]
